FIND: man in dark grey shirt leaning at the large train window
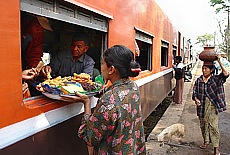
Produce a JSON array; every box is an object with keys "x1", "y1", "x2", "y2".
[{"x1": 42, "y1": 32, "x2": 95, "y2": 78}]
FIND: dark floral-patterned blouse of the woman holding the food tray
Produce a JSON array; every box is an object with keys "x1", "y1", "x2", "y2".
[{"x1": 78, "y1": 79, "x2": 146, "y2": 155}]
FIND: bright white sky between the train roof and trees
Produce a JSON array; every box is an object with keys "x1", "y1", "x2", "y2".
[{"x1": 155, "y1": 0, "x2": 224, "y2": 49}]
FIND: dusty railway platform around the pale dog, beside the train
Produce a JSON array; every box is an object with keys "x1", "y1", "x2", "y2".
[{"x1": 146, "y1": 61, "x2": 230, "y2": 155}]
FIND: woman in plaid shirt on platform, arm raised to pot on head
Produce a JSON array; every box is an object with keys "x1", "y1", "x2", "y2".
[{"x1": 192, "y1": 56, "x2": 229, "y2": 155}]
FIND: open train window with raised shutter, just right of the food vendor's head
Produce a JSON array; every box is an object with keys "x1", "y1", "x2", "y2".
[{"x1": 135, "y1": 28, "x2": 153, "y2": 71}]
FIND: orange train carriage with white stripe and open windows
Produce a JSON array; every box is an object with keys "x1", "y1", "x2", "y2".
[{"x1": 0, "y1": 0, "x2": 192, "y2": 155}]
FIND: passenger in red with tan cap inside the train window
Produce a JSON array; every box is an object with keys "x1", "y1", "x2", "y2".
[{"x1": 21, "y1": 16, "x2": 53, "y2": 70}]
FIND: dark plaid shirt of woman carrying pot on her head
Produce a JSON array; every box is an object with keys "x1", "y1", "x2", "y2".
[{"x1": 192, "y1": 73, "x2": 228, "y2": 118}]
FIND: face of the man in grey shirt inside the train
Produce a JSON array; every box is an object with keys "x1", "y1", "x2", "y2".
[{"x1": 70, "y1": 41, "x2": 89, "y2": 58}]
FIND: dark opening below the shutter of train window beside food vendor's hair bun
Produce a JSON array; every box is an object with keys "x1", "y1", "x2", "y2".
[{"x1": 136, "y1": 40, "x2": 152, "y2": 71}]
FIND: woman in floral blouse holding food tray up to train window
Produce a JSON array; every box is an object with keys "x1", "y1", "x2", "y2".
[{"x1": 60, "y1": 45, "x2": 146, "y2": 155}]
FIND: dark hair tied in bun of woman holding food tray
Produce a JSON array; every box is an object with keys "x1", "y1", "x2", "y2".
[{"x1": 103, "y1": 45, "x2": 141, "y2": 78}]
